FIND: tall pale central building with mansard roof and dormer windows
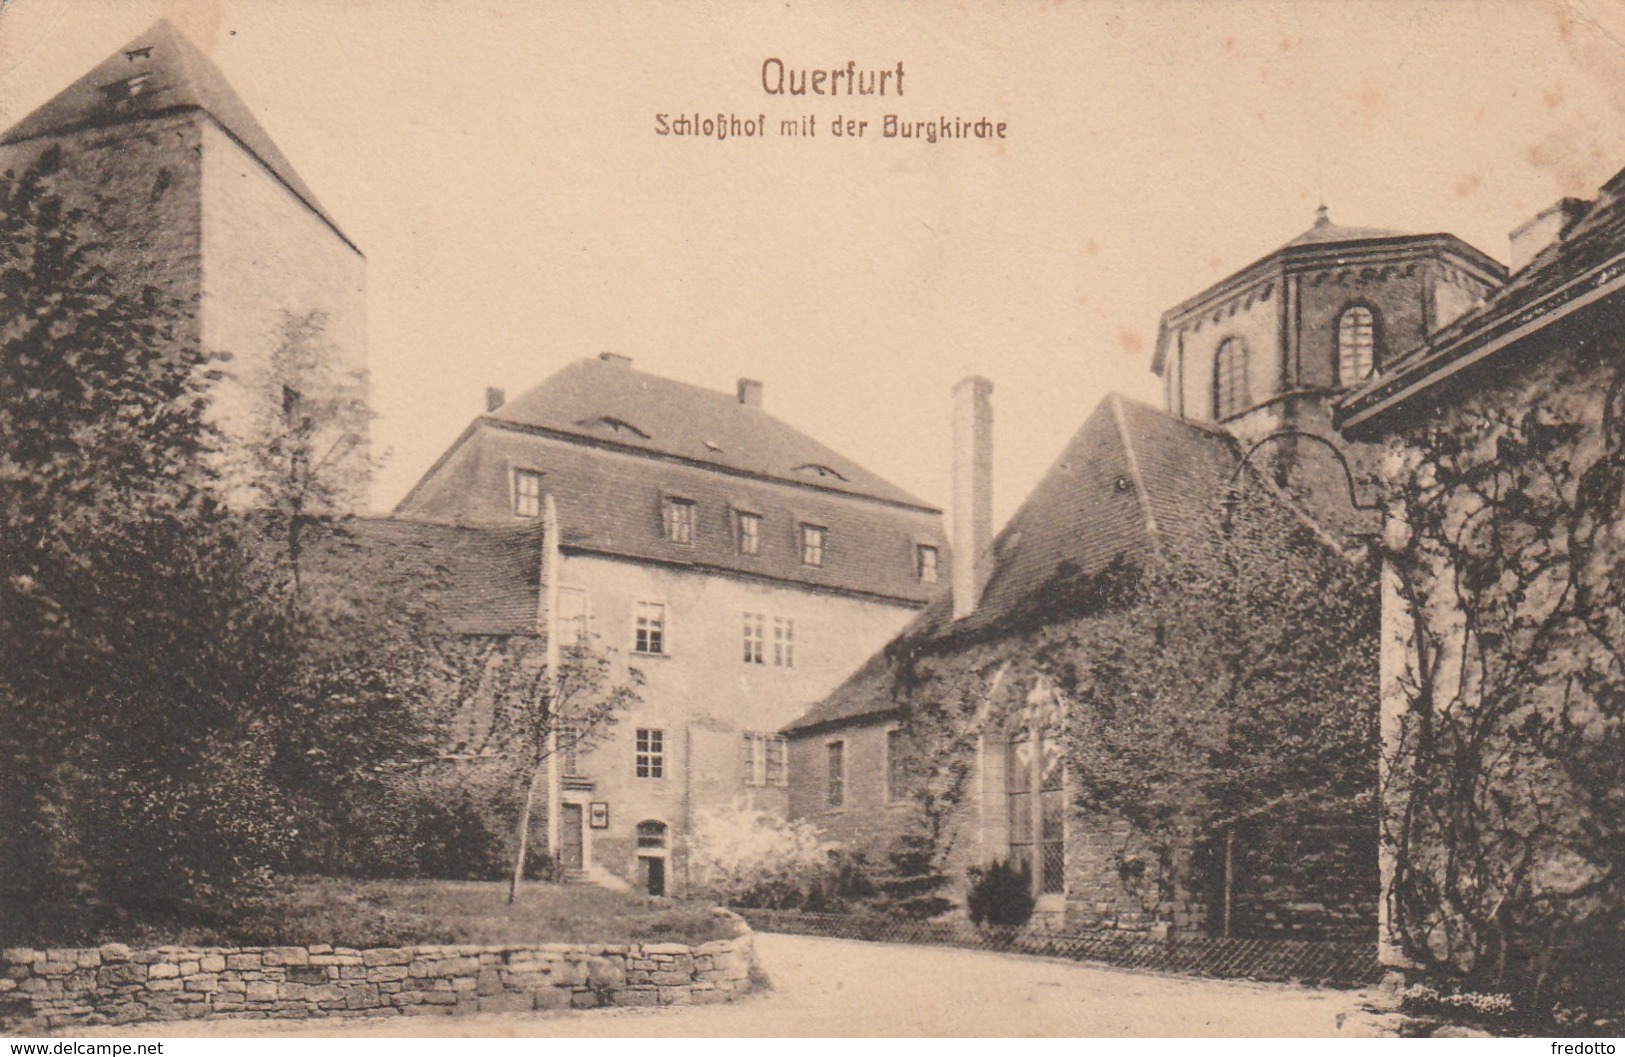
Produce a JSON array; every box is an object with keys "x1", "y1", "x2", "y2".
[{"x1": 395, "y1": 353, "x2": 951, "y2": 893}]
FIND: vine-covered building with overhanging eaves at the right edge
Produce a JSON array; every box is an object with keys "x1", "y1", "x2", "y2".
[{"x1": 1334, "y1": 171, "x2": 1625, "y2": 985}]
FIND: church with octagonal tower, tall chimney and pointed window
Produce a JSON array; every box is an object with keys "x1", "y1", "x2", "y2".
[{"x1": 785, "y1": 208, "x2": 1506, "y2": 937}]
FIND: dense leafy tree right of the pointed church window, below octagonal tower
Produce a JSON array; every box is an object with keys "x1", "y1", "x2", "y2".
[{"x1": 1035, "y1": 481, "x2": 1380, "y2": 924}]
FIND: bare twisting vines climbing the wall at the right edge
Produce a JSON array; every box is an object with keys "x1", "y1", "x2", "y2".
[{"x1": 1383, "y1": 350, "x2": 1625, "y2": 1013}]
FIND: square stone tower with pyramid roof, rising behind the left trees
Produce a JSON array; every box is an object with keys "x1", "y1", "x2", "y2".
[{"x1": 0, "y1": 21, "x2": 369, "y2": 507}]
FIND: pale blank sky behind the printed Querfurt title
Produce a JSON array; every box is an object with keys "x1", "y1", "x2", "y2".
[{"x1": 0, "y1": 0, "x2": 1625, "y2": 522}]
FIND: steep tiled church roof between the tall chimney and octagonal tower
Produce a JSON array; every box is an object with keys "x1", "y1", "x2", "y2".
[{"x1": 787, "y1": 394, "x2": 1240, "y2": 732}]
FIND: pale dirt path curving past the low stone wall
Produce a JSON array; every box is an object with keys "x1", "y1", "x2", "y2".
[{"x1": 73, "y1": 933, "x2": 1380, "y2": 1037}]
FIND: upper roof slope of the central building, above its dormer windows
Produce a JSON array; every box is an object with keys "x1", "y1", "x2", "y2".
[{"x1": 489, "y1": 359, "x2": 933, "y2": 509}]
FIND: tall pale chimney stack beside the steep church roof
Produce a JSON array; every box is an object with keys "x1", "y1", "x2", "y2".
[{"x1": 952, "y1": 374, "x2": 993, "y2": 620}]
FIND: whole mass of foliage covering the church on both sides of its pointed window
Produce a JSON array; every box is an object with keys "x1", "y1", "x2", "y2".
[{"x1": 887, "y1": 478, "x2": 1380, "y2": 930}]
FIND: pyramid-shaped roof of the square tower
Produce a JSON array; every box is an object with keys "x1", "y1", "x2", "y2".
[{"x1": 0, "y1": 20, "x2": 338, "y2": 242}]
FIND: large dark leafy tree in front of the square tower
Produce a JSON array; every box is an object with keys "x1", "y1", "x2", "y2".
[{"x1": 0, "y1": 148, "x2": 299, "y2": 927}]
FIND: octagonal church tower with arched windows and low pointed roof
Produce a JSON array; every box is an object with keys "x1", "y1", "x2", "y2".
[{"x1": 1152, "y1": 207, "x2": 1506, "y2": 512}]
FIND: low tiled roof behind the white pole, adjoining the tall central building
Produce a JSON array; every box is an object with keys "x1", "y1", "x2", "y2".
[{"x1": 306, "y1": 517, "x2": 541, "y2": 636}]
